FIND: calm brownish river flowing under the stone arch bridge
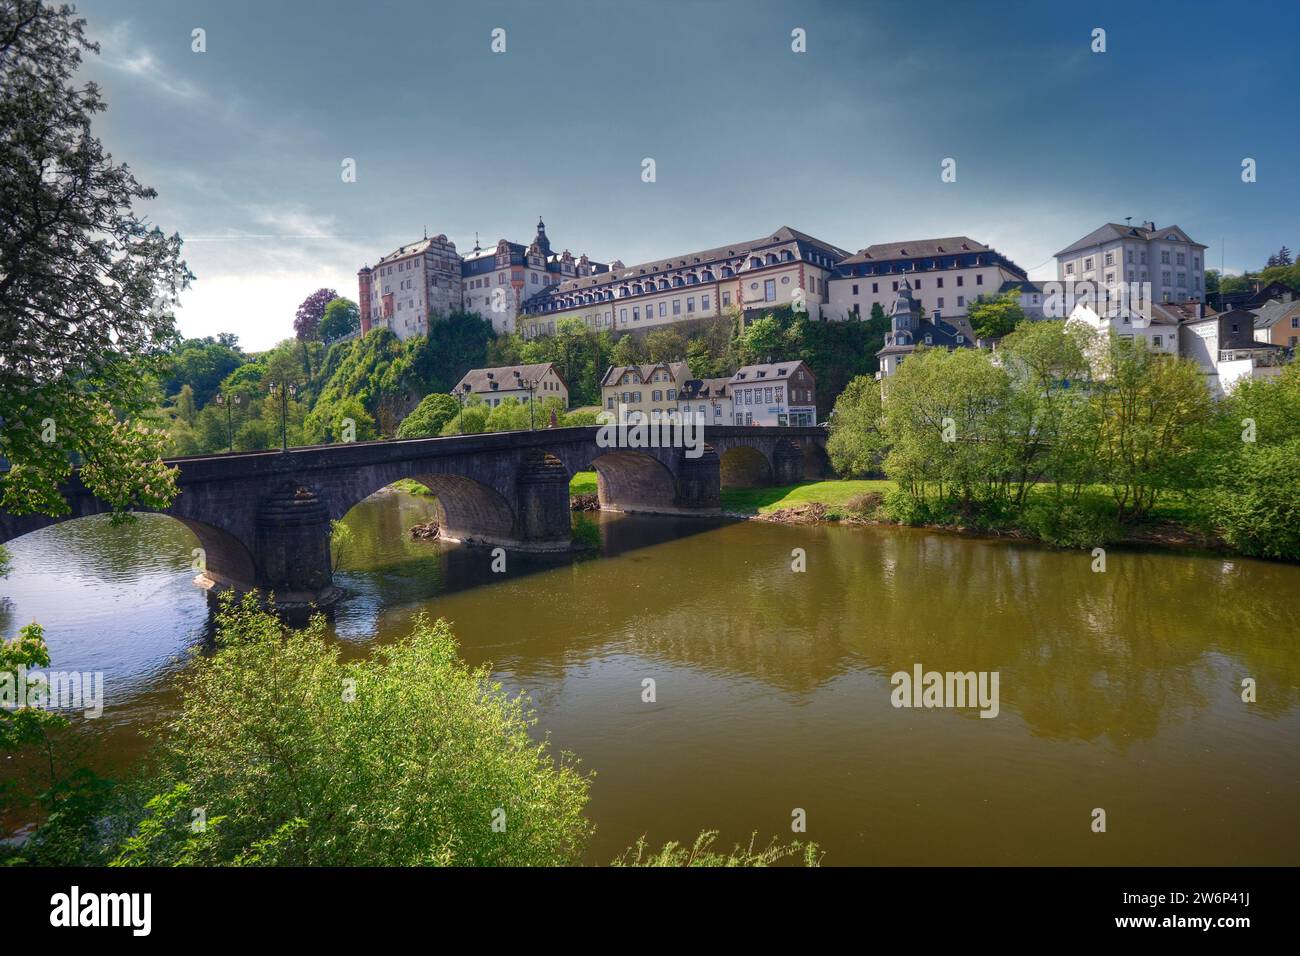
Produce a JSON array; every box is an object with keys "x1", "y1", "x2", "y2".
[{"x1": 0, "y1": 492, "x2": 1300, "y2": 865}]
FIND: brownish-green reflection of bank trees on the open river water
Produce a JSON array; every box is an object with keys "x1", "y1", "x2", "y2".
[{"x1": 473, "y1": 523, "x2": 1300, "y2": 747}]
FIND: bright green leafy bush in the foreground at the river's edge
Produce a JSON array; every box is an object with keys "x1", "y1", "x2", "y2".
[{"x1": 118, "y1": 597, "x2": 592, "y2": 866}]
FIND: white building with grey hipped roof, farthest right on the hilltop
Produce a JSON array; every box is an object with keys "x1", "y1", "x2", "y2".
[{"x1": 1056, "y1": 222, "x2": 1205, "y2": 302}]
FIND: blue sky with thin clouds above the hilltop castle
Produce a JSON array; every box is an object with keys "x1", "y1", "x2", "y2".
[{"x1": 77, "y1": 0, "x2": 1300, "y2": 349}]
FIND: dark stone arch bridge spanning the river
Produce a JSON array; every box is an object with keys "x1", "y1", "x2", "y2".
[{"x1": 0, "y1": 425, "x2": 826, "y2": 604}]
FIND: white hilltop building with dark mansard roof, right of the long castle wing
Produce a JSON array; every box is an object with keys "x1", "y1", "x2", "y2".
[{"x1": 822, "y1": 235, "x2": 1041, "y2": 319}]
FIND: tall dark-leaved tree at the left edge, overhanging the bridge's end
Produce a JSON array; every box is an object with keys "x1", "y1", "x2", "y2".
[{"x1": 0, "y1": 0, "x2": 191, "y2": 514}]
